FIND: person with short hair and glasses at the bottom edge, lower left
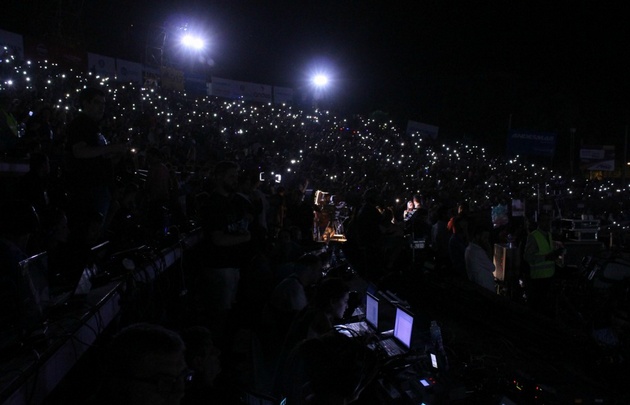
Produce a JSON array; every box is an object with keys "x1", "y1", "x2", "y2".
[{"x1": 87, "y1": 323, "x2": 190, "y2": 405}]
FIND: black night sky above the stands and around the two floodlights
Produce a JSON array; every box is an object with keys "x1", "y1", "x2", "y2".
[{"x1": 0, "y1": 0, "x2": 630, "y2": 150}]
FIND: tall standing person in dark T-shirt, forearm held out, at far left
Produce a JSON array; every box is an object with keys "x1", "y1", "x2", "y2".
[{"x1": 66, "y1": 87, "x2": 127, "y2": 230}]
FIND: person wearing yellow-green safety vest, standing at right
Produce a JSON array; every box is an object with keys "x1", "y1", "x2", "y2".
[{"x1": 523, "y1": 214, "x2": 563, "y2": 317}]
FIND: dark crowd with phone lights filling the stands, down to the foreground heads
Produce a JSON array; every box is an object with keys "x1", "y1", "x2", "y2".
[{"x1": 0, "y1": 48, "x2": 628, "y2": 404}]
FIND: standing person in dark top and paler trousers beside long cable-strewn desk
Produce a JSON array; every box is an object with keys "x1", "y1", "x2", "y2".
[{"x1": 201, "y1": 161, "x2": 252, "y2": 348}]
